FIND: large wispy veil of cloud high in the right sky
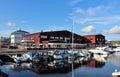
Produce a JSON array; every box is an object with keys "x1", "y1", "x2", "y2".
[{"x1": 70, "y1": 6, "x2": 120, "y2": 25}]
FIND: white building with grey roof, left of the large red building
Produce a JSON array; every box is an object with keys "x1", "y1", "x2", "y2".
[{"x1": 10, "y1": 30, "x2": 29, "y2": 46}]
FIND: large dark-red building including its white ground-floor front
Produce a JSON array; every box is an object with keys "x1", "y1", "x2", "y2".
[{"x1": 23, "y1": 30, "x2": 85, "y2": 48}]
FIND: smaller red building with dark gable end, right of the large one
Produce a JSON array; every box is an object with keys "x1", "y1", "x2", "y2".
[{"x1": 84, "y1": 34, "x2": 105, "y2": 46}]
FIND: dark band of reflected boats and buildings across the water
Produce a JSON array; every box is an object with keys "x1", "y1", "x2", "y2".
[{"x1": 6, "y1": 57, "x2": 105, "y2": 74}]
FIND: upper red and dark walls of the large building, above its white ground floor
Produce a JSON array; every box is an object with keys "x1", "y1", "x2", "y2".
[{"x1": 23, "y1": 30, "x2": 86, "y2": 44}]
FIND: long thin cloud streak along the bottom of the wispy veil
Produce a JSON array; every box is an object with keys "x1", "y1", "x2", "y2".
[{"x1": 74, "y1": 15, "x2": 120, "y2": 25}]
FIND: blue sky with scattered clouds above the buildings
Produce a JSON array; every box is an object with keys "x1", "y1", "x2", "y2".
[{"x1": 0, "y1": 0, "x2": 120, "y2": 40}]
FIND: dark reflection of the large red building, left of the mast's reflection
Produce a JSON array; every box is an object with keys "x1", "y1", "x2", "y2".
[{"x1": 29, "y1": 60, "x2": 68, "y2": 74}]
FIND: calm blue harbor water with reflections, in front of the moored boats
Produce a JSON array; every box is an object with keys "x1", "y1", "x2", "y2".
[{"x1": 0, "y1": 52, "x2": 120, "y2": 77}]
